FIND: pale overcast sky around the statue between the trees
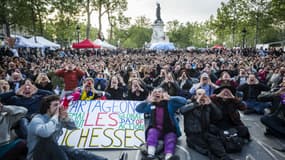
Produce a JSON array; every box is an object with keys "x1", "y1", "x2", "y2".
[{"x1": 91, "y1": 0, "x2": 228, "y2": 33}]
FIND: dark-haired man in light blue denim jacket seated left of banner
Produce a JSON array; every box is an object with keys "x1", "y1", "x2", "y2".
[{"x1": 27, "y1": 95, "x2": 110, "y2": 160}]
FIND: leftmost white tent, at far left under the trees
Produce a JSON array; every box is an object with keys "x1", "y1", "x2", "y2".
[{"x1": 12, "y1": 35, "x2": 44, "y2": 48}]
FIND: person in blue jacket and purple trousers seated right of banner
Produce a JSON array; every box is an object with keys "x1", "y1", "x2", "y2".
[{"x1": 136, "y1": 88, "x2": 186, "y2": 160}]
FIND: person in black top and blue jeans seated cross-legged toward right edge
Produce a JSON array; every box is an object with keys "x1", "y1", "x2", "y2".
[{"x1": 237, "y1": 74, "x2": 271, "y2": 114}]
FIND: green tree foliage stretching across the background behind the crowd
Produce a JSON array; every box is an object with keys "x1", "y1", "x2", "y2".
[{"x1": 0, "y1": 0, "x2": 285, "y2": 48}]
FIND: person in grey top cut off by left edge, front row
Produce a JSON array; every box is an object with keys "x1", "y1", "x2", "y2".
[{"x1": 0, "y1": 102, "x2": 28, "y2": 160}]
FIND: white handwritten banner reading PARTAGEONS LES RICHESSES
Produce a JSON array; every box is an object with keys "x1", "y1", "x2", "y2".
[{"x1": 58, "y1": 100, "x2": 145, "y2": 149}]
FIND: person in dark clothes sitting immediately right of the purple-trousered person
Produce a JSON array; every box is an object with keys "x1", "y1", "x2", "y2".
[{"x1": 180, "y1": 89, "x2": 234, "y2": 160}]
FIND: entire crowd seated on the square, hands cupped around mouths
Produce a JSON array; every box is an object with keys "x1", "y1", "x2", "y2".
[{"x1": 0, "y1": 47, "x2": 285, "y2": 160}]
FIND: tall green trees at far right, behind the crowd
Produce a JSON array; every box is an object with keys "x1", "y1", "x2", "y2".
[{"x1": 210, "y1": 0, "x2": 285, "y2": 47}]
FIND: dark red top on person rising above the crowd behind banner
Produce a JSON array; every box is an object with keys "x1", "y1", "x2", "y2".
[{"x1": 55, "y1": 68, "x2": 84, "y2": 91}]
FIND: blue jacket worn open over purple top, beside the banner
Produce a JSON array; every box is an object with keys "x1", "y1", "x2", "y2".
[{"x1": 136, "y1": 96, "x2": 187, "y2": 137}]
